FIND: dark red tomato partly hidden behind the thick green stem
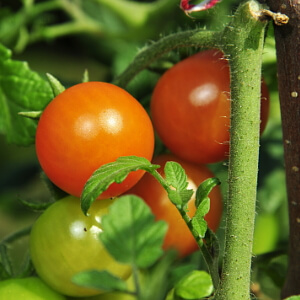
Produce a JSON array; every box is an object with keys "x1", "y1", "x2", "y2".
[{"x1": 151, "y1": 49, "x2": 269, "y2": 163}]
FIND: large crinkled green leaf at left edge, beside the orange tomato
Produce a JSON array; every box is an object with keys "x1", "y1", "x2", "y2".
[{"x1": 0, "y1": 44, "x2": 53, "y2": 145}]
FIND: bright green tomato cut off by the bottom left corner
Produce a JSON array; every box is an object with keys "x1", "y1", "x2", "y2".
[{"x1": 0, "y1": 277, "x2": 66, "y2": 300}]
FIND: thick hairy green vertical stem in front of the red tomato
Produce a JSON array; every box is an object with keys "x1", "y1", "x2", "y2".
[{"x1": 215, "y1": 1, "x2": 266, "y2": 300}]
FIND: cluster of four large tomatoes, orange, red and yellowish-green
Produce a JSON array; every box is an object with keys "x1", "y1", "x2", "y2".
[{"x1": 30, "y1": 50, "x2": 269, "y2": 297}]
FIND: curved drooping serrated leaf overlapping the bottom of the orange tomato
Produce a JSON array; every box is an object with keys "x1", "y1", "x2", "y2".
[{"x1": 81, "y1": 156, "x2": 159, "y2": 214}]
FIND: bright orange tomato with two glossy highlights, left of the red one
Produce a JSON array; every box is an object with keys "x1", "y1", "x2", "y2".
[{"x1": 36, "y1": 82, "x2": 154, "y2": 199}]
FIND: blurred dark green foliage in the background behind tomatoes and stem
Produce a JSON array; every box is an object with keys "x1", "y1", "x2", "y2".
[{"x1": 0, "y1": 0, "x2": 288, "y2": 299}]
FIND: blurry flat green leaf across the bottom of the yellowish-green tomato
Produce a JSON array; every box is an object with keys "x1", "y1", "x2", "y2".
[{"x1": 72, "y1": 270, "x2": 127, "y2": 292}]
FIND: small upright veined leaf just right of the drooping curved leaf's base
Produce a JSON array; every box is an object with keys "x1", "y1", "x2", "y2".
[{"x1": 164, "y1": 161, "x2": 188, "y2": 191}]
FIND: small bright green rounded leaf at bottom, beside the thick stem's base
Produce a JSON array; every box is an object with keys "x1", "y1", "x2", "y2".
[{"x1": 174, "y1": 270, "x2": 213, "y2": 300}]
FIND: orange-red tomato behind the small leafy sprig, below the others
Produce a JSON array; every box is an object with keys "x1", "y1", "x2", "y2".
[{"x1": 127, "y1": 154, "x2": 223, "y2": 257}]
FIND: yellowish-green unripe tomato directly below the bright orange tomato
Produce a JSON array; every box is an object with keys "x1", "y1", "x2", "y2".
[{"x1": 30, "y1": 196, "x2": 130, "y2": 297}]
